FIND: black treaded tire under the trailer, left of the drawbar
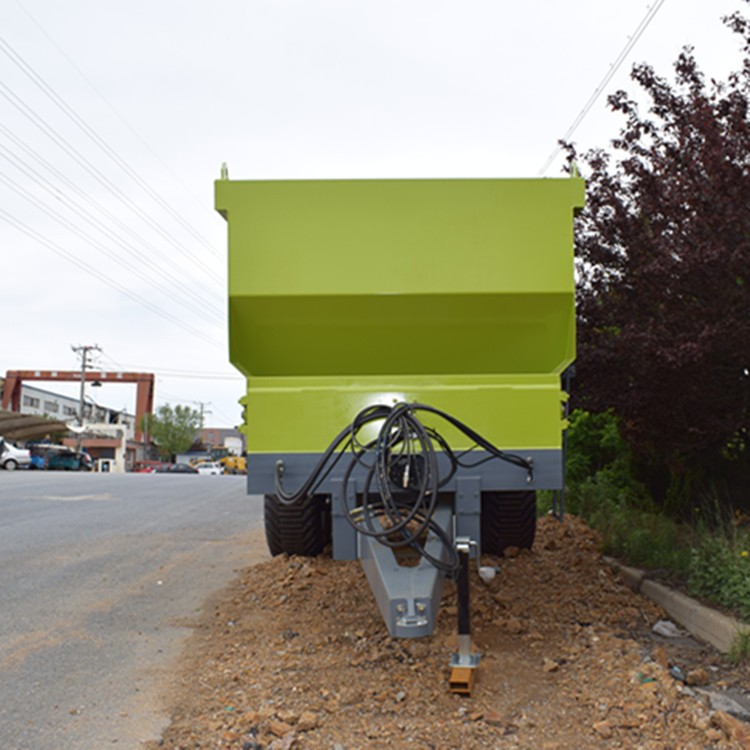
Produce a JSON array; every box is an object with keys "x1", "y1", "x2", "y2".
[{"x1": 263, "y1": 495, "x2": 331, "y2": 557}]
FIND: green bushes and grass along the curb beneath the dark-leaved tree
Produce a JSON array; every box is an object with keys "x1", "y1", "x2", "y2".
[{"x1": 560, "y1": 412, "x2": 750, "y2": 624}]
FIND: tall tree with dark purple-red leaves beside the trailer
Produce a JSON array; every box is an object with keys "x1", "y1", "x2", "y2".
[{"x1": 567, "y1": 5, "x2": 750, "y2": 508}]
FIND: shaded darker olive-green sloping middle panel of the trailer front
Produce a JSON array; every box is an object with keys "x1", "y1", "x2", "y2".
[{"x1": 230, "y1": 293, "x2": 575, "y2": 376}]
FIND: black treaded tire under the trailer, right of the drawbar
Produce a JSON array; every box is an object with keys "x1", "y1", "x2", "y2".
[{"x1": 481, "y1": 490, "x2": 536, "y2": 555}]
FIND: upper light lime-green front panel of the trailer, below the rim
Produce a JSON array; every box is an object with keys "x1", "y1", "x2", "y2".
[{"x1": 216, "y1": 178, "x2": 583, "y2": 296}]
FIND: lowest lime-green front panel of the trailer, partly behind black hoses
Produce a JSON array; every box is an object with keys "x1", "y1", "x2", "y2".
[{"x1": 246, "y1": 376, "x2": 562, "y2": 453}]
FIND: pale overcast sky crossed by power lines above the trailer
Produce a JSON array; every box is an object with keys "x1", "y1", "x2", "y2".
[{"x1": 0, "y1": 0, "x2": 750, "y2": 426}]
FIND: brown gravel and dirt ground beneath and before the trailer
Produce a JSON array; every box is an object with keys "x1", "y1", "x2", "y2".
[{"x1": 149, "y1": 517, "x2": 750, "y2": 750}]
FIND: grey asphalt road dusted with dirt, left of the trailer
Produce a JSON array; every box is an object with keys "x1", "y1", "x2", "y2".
[{"x1": 0, "y1": 471, "x2": 267, "y2": 750}]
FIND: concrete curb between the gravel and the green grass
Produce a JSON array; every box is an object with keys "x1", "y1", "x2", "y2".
[{"x1": 603, "y1": 557, "x2": 750, "y2": 654}]
